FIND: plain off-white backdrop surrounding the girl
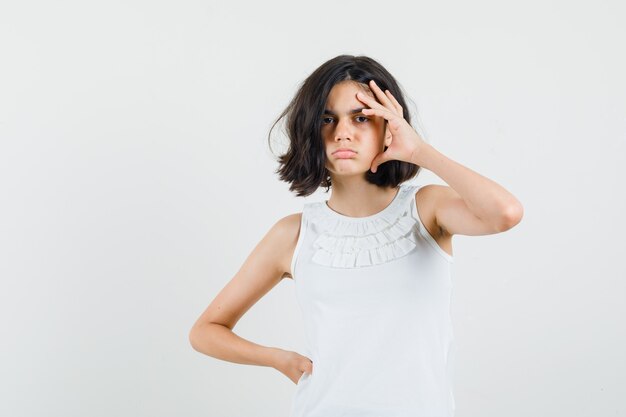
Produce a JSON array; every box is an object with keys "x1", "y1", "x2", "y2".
[{"x1": 0, "y1": 0, "x2": 626, "y2": 417}]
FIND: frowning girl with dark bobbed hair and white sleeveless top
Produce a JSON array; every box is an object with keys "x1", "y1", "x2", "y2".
[{"x1": 190, "y1": 55, "x2": 523, "y2": 417}]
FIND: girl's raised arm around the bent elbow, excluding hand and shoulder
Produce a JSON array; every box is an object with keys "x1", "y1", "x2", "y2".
[{"x1": 411, "y1": 144, "x2": 524, "y2": 236}]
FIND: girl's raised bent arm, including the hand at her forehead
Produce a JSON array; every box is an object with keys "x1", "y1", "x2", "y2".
[{"x1": 357, "y1": 80, "x2": 524, "y2": 234}]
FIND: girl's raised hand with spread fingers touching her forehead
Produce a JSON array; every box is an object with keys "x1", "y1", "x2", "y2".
[{"x1": 357, "y1": 80, "x2": 427, "y2": 172}]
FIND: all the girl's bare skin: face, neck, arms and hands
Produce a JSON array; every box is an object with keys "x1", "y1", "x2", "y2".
[{"x1": 189, "y1": 81, "x2": 523, "y2": 383}]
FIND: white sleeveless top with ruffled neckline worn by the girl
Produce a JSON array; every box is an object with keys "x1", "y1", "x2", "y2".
[{"x1": 290, "y1": 183, "x2": 455, "y2": 417}]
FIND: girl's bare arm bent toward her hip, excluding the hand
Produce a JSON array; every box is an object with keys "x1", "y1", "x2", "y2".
[{"x1": 189, "y1": 214, "x2": 300, "y2": 368}]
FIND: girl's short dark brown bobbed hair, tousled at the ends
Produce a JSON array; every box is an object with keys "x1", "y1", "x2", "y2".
[{"x1": 268, "y1": 55, "x2": 421, "y2": 197}]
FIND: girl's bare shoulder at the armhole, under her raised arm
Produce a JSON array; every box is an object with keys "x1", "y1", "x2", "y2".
[{"x1": 415, "y1": 184, "x2": 453, "y2": 256}]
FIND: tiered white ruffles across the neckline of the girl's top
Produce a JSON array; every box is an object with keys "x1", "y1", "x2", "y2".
[{"x1": 309, "y1": 185, "x2": 417, "y2": 268}]
